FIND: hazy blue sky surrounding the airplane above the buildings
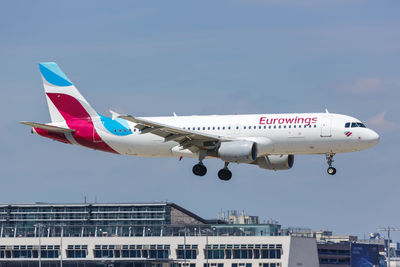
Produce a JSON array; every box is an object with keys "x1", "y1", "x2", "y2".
[{"x1": 0, "y1": 0, "x2": 400, "y2": 239}]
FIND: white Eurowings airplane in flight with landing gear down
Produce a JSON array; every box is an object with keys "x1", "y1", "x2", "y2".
[{"x1": 20, "y1": 62, "x2": 379, "y2": 181}]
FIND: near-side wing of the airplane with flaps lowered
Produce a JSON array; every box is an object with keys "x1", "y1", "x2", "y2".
[{"x1": 118, "y1": 115, "x2": 232, "y2": 152}]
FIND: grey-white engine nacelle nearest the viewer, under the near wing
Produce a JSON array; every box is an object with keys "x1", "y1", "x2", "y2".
[{"x1": 218, "y1": 141, "x2": 257, "y2": 163}]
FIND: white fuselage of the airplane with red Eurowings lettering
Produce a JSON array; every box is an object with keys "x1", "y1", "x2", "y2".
[{"x1": 95, "y1": 113, "x2": 379, "y2": 157}]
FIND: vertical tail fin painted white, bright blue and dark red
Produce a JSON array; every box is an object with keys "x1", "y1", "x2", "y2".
[{"x1": 39, "y1": 62, "x2": 98, "y2": 122}]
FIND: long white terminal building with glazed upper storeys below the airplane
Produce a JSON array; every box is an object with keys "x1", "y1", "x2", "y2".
[{"x1": 0, "y1": 203, "x2": 319, "y2": 267}]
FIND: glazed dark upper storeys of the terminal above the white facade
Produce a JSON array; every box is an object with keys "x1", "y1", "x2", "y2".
[{"x1": 0, "y1": 203, "x2": 280, "y2": 240}]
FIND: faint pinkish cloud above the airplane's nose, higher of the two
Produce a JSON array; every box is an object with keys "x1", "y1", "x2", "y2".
[{"x1": 340, "y1": 78, "x2": 390, "y2": 94}]
